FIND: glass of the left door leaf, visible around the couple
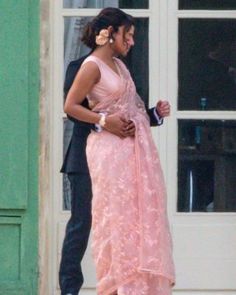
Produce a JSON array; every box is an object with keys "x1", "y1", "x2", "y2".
[{"x1": 63, "y1": 17, "x2": 149, "y2": 209}]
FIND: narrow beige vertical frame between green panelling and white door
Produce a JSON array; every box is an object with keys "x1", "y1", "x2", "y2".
[{"x1": 39, "y1": 0, "x2": 54, "y2": 295}]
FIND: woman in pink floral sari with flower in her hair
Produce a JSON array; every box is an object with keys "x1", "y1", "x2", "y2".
[{"x1": 65, "y1": 8, "x2": 174, "y2": 295}]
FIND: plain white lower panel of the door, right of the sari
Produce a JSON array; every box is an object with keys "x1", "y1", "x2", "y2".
[{"x1": 173, "y1": 223, "x2": 236, "y2": 290}]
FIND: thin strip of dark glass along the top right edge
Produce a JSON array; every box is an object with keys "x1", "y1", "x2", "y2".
[{"x1": 179, "y1": 0, "x2": 236, "y2": 10}]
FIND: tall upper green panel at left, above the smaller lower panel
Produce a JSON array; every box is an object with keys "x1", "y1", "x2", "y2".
[{"x1": 0, "y1": 0, "x2": 29, "y2": 209}]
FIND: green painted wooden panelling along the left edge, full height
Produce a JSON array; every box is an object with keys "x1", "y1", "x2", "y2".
[{"x1": 0, "y1": 0, "x2": 40, "y2": 295}]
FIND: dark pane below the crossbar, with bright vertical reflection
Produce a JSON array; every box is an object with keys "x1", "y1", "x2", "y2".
[{"x1": 177, "y1": 120, "x2": 236, "y2": 212}]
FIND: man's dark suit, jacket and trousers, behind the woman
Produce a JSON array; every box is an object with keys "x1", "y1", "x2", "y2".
[{"x1": 59, "y1": 56, "x2": 162, "y2": 295}]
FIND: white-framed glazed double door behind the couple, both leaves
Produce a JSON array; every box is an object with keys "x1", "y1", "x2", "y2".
[{"x1": 51, "y1": 0, "x2": 236, "y2": 295}]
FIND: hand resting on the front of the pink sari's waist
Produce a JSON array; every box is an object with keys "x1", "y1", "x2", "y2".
[{"x1": 103, "y1": 114, "x2": 135, "y2": 138}]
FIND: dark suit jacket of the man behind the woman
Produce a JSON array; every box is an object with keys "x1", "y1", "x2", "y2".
[{"x1": 61, "y1": 55, "x2": 160, "y2": 173}]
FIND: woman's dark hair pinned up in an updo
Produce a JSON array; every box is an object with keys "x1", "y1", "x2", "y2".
[{"x1": 81, "y1": 7, "x2": 134, "y2": 50}]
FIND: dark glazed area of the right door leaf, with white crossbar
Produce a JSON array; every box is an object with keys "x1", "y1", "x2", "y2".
[{"x1": 176, "y1": 4, "x2": 236, "y2": 212}]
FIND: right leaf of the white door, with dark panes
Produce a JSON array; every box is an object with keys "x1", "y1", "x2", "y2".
[{"x1": 166, "y1": 0, "x2": 236, "y2": 295}]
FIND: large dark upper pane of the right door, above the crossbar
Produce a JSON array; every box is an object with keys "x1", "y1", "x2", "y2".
[{"x1": 178, "y1": 19, "x2": 236, "y2": 110}]
